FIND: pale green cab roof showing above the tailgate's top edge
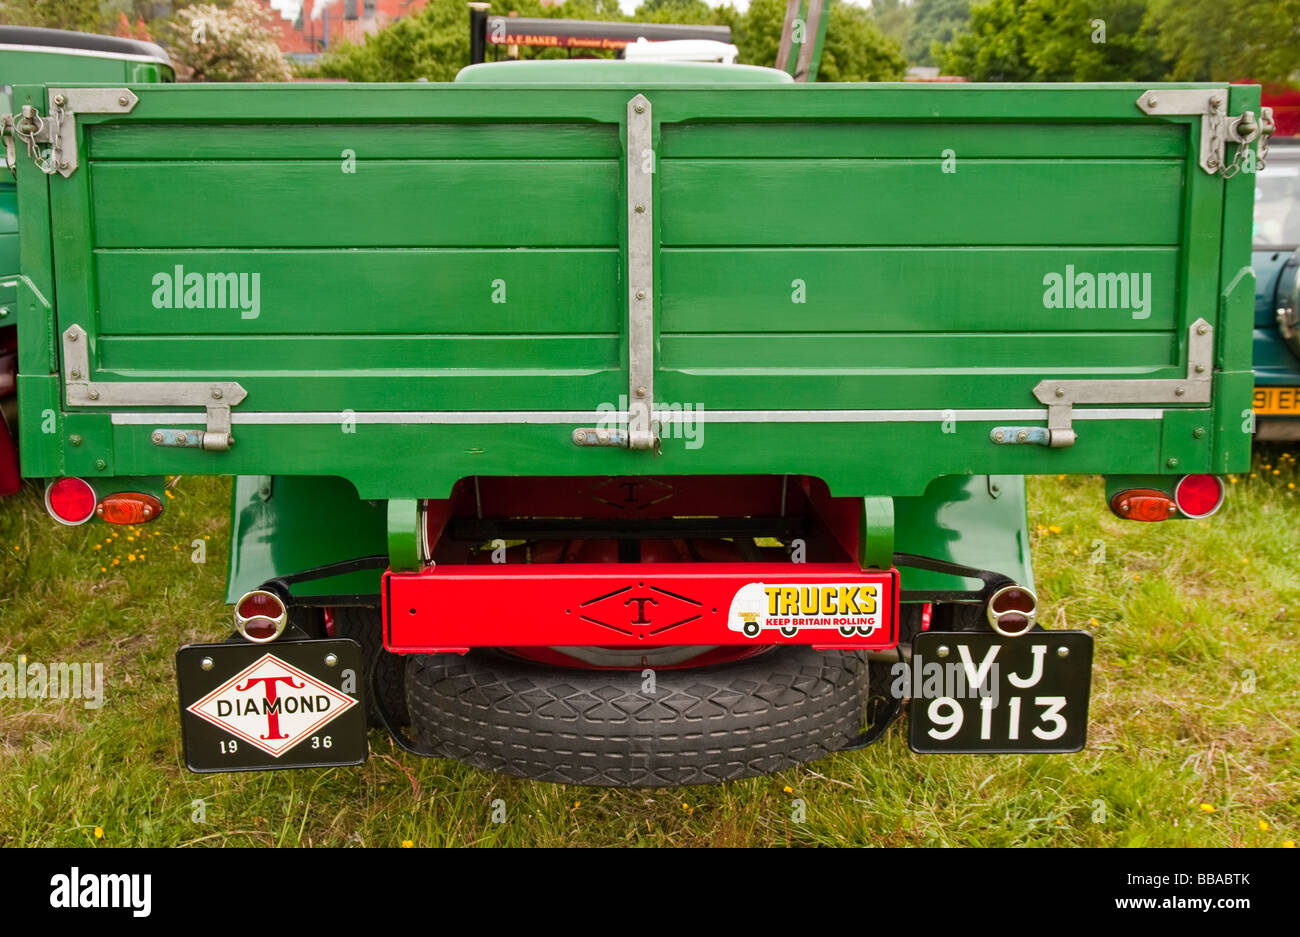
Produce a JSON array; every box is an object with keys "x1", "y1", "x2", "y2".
[{"x1": 456, "y1": 58, "x2": 794, "y2": 84}]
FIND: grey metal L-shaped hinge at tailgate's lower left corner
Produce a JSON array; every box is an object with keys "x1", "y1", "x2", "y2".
[{"x1": 64, "y1": 325, "x2": 248, "y2": 452}]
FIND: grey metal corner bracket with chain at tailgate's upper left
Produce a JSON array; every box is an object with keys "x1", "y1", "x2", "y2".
[{"x1": 0, "y1": 88, "x2": 139, "y2": 178}]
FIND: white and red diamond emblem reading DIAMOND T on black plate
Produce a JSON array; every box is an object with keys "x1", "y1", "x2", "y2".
[{"x1": 189, "y1": 654, "x2": 356, "y2": 758}]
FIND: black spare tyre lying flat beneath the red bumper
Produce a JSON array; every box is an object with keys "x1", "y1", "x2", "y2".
[{"x1": 406, "y1": 646, "x2": 867, "y2": 788}]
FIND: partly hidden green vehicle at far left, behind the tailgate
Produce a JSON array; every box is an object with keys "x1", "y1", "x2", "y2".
[{"x1": 0, "y1": 26, "x2": 176, "y2": 495}]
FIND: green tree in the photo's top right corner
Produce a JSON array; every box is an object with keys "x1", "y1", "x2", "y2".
[{"x1": 1149, "y1": 0, "x2": 1300, "y2": 82}]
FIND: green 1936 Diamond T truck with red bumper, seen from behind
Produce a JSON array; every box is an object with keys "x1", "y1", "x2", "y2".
[{"x1": 10, "y1": 61, "x2": 1268, "y2": 785}]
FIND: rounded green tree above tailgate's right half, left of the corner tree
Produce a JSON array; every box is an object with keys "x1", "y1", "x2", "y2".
[{"x1": 939, "y1": 0, "x2": 1167, "y2": 82}]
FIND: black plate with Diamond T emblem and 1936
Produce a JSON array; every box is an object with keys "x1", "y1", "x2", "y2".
[{"x1": 176, "y1": 638, "x2": 369, "y2": 773}]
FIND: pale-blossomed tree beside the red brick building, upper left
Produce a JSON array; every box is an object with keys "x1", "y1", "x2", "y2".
[{"x1": 168, "y1": 0, "x2": 293, "y2": 82}]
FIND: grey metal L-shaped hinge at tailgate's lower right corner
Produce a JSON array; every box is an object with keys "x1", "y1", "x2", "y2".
[{"x1": 1019, "y1": 318, "x2": 1214, "y2": 448}]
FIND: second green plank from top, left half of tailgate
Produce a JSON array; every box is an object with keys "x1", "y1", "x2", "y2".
[{"x1": 90, "y1": 160, "x2": 619, "y2": 250}]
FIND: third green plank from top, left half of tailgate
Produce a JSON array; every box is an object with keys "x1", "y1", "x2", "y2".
[{"x1": 96, "y1": 247, "x2": 619, "y2": 335}]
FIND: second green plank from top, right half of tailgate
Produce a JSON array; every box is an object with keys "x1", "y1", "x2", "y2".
[{"x1": 660, "y1": 161, "x2": 1184, "y2": 246}]
